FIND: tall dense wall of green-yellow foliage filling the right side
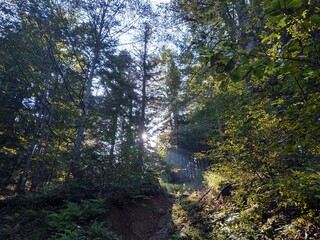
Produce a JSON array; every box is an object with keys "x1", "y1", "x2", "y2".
[{"x1": 166, "y1": 0, "x2": 320, "y2": 239}]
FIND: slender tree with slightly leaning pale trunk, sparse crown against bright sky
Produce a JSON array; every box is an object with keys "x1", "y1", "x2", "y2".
[{"x1": 57, "y1": 1, "x2": 125, "y2": 178}]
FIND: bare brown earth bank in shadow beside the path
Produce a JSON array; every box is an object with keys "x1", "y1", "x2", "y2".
[{"x1": 107, "y1": 193, "x2": 172, "y2": 240}]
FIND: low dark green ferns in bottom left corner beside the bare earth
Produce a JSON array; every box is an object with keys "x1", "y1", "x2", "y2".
[{"x1": 0, "y1": 193, "x2": 117, "y2": 240}]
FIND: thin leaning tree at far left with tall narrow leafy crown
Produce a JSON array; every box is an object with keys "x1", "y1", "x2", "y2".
[{"x1": 3, "y1": 2, "x2": 66, "y2": 192}]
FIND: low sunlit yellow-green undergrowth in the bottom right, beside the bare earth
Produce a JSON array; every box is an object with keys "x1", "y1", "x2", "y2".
[{"x1": 170, "y1": 166, "x2": 320, "y2": 240}]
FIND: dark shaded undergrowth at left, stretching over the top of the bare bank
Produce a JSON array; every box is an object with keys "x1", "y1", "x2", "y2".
[{"x1": 0, "y1": 176, "x2": 159, "y2": 240}]
